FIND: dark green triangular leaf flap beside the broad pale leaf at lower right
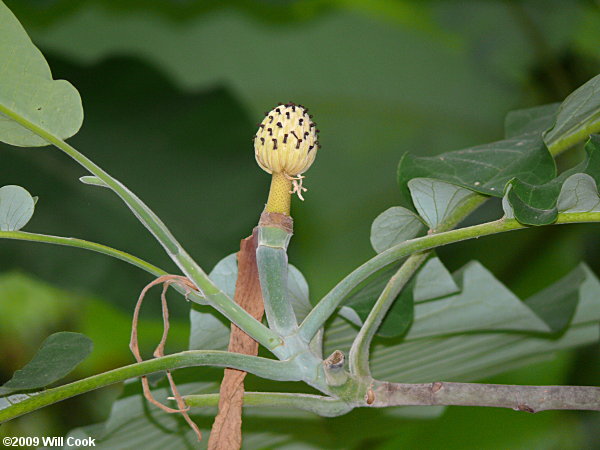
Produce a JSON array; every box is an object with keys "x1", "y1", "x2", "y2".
[{"x1": 525, "y1": 265, "x2": 586, "y2": 333}]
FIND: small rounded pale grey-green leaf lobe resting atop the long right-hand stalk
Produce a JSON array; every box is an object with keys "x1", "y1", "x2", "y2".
[{"x1": 371, "y1": 206, "x2": 423, "y2": 253}]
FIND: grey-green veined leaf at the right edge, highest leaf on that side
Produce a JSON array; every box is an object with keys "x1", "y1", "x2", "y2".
[{"x1": 544, "y1": 75, "x2": 600, "y2": 147}]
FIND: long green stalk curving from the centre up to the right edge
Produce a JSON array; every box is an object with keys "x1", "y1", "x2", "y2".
[{"x1": 299, "y1": 212, "x2": 600, "y2": 342}]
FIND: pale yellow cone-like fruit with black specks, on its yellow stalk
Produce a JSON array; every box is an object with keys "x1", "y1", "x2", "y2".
[{"x1": 254, "y1": 102, "x2": 320, "y2": 215}]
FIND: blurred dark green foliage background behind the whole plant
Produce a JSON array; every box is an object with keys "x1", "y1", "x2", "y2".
[{"x1": 0, "y1": 0, "x2": 600, "y2": 449}]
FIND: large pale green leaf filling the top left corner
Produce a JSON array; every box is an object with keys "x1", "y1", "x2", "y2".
[{"x1": 0, "y1": 1, "x2": 83, "y2": 147}]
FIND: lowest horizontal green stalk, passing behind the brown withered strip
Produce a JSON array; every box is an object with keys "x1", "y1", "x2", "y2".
[{"x1": 183, "y1": 392, "x2": 352, "y2": 417}]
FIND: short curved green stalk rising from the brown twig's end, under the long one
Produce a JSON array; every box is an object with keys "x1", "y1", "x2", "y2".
[{"x1": 348, "y1": 252, "x2": 429, "y2": 377}]
